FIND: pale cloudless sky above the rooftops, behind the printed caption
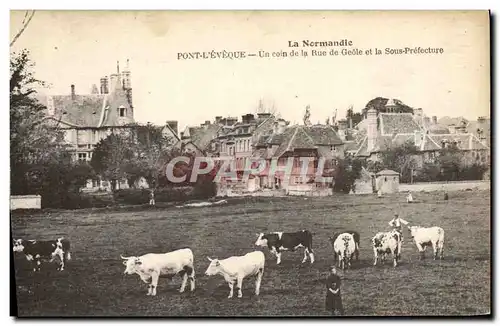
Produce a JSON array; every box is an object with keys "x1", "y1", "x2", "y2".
[{"x1": 10, "y1": 11, "x2": 490, "y2": 129}]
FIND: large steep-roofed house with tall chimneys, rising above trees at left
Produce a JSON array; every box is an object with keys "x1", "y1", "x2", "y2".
[{"x1": 38, "y1": 60, "x2": 179, "y2": 190}]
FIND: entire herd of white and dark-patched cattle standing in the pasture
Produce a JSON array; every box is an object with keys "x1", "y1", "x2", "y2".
[{"x1": 13, "y1": 226, "x2": 444, "y2": 298}]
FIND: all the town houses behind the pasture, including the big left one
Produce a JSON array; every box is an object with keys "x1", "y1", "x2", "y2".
[{"x1": 39, "y1": 62, "x2": 490, "y2": 194}]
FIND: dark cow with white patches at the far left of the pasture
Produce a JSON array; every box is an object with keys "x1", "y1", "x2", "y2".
[{"x1": 12, "y1": 237, "x2": 71, "y2": 272}]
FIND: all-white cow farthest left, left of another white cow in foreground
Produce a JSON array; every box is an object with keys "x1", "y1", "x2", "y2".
[{"x1": 120, "y1": 248, "x2": 195, "y2": 296}]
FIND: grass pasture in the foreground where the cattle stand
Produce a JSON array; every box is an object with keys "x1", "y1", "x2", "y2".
[{"x1": 12, "y1": 192, "x2": 491, "y2": 316}]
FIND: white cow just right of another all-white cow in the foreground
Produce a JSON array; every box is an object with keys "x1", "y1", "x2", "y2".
[{"x1": 205, "y1": 251, "x2": 266, "y2": 299}]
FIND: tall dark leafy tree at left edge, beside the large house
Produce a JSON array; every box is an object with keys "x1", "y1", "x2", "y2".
[{"x1": 10, "y1": 50, "x2": 70, "y2": 195}]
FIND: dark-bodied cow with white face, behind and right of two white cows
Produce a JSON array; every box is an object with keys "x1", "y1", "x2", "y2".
[{"x1": 255, "y1": 230, "x2": 314, "y2": 265}]
